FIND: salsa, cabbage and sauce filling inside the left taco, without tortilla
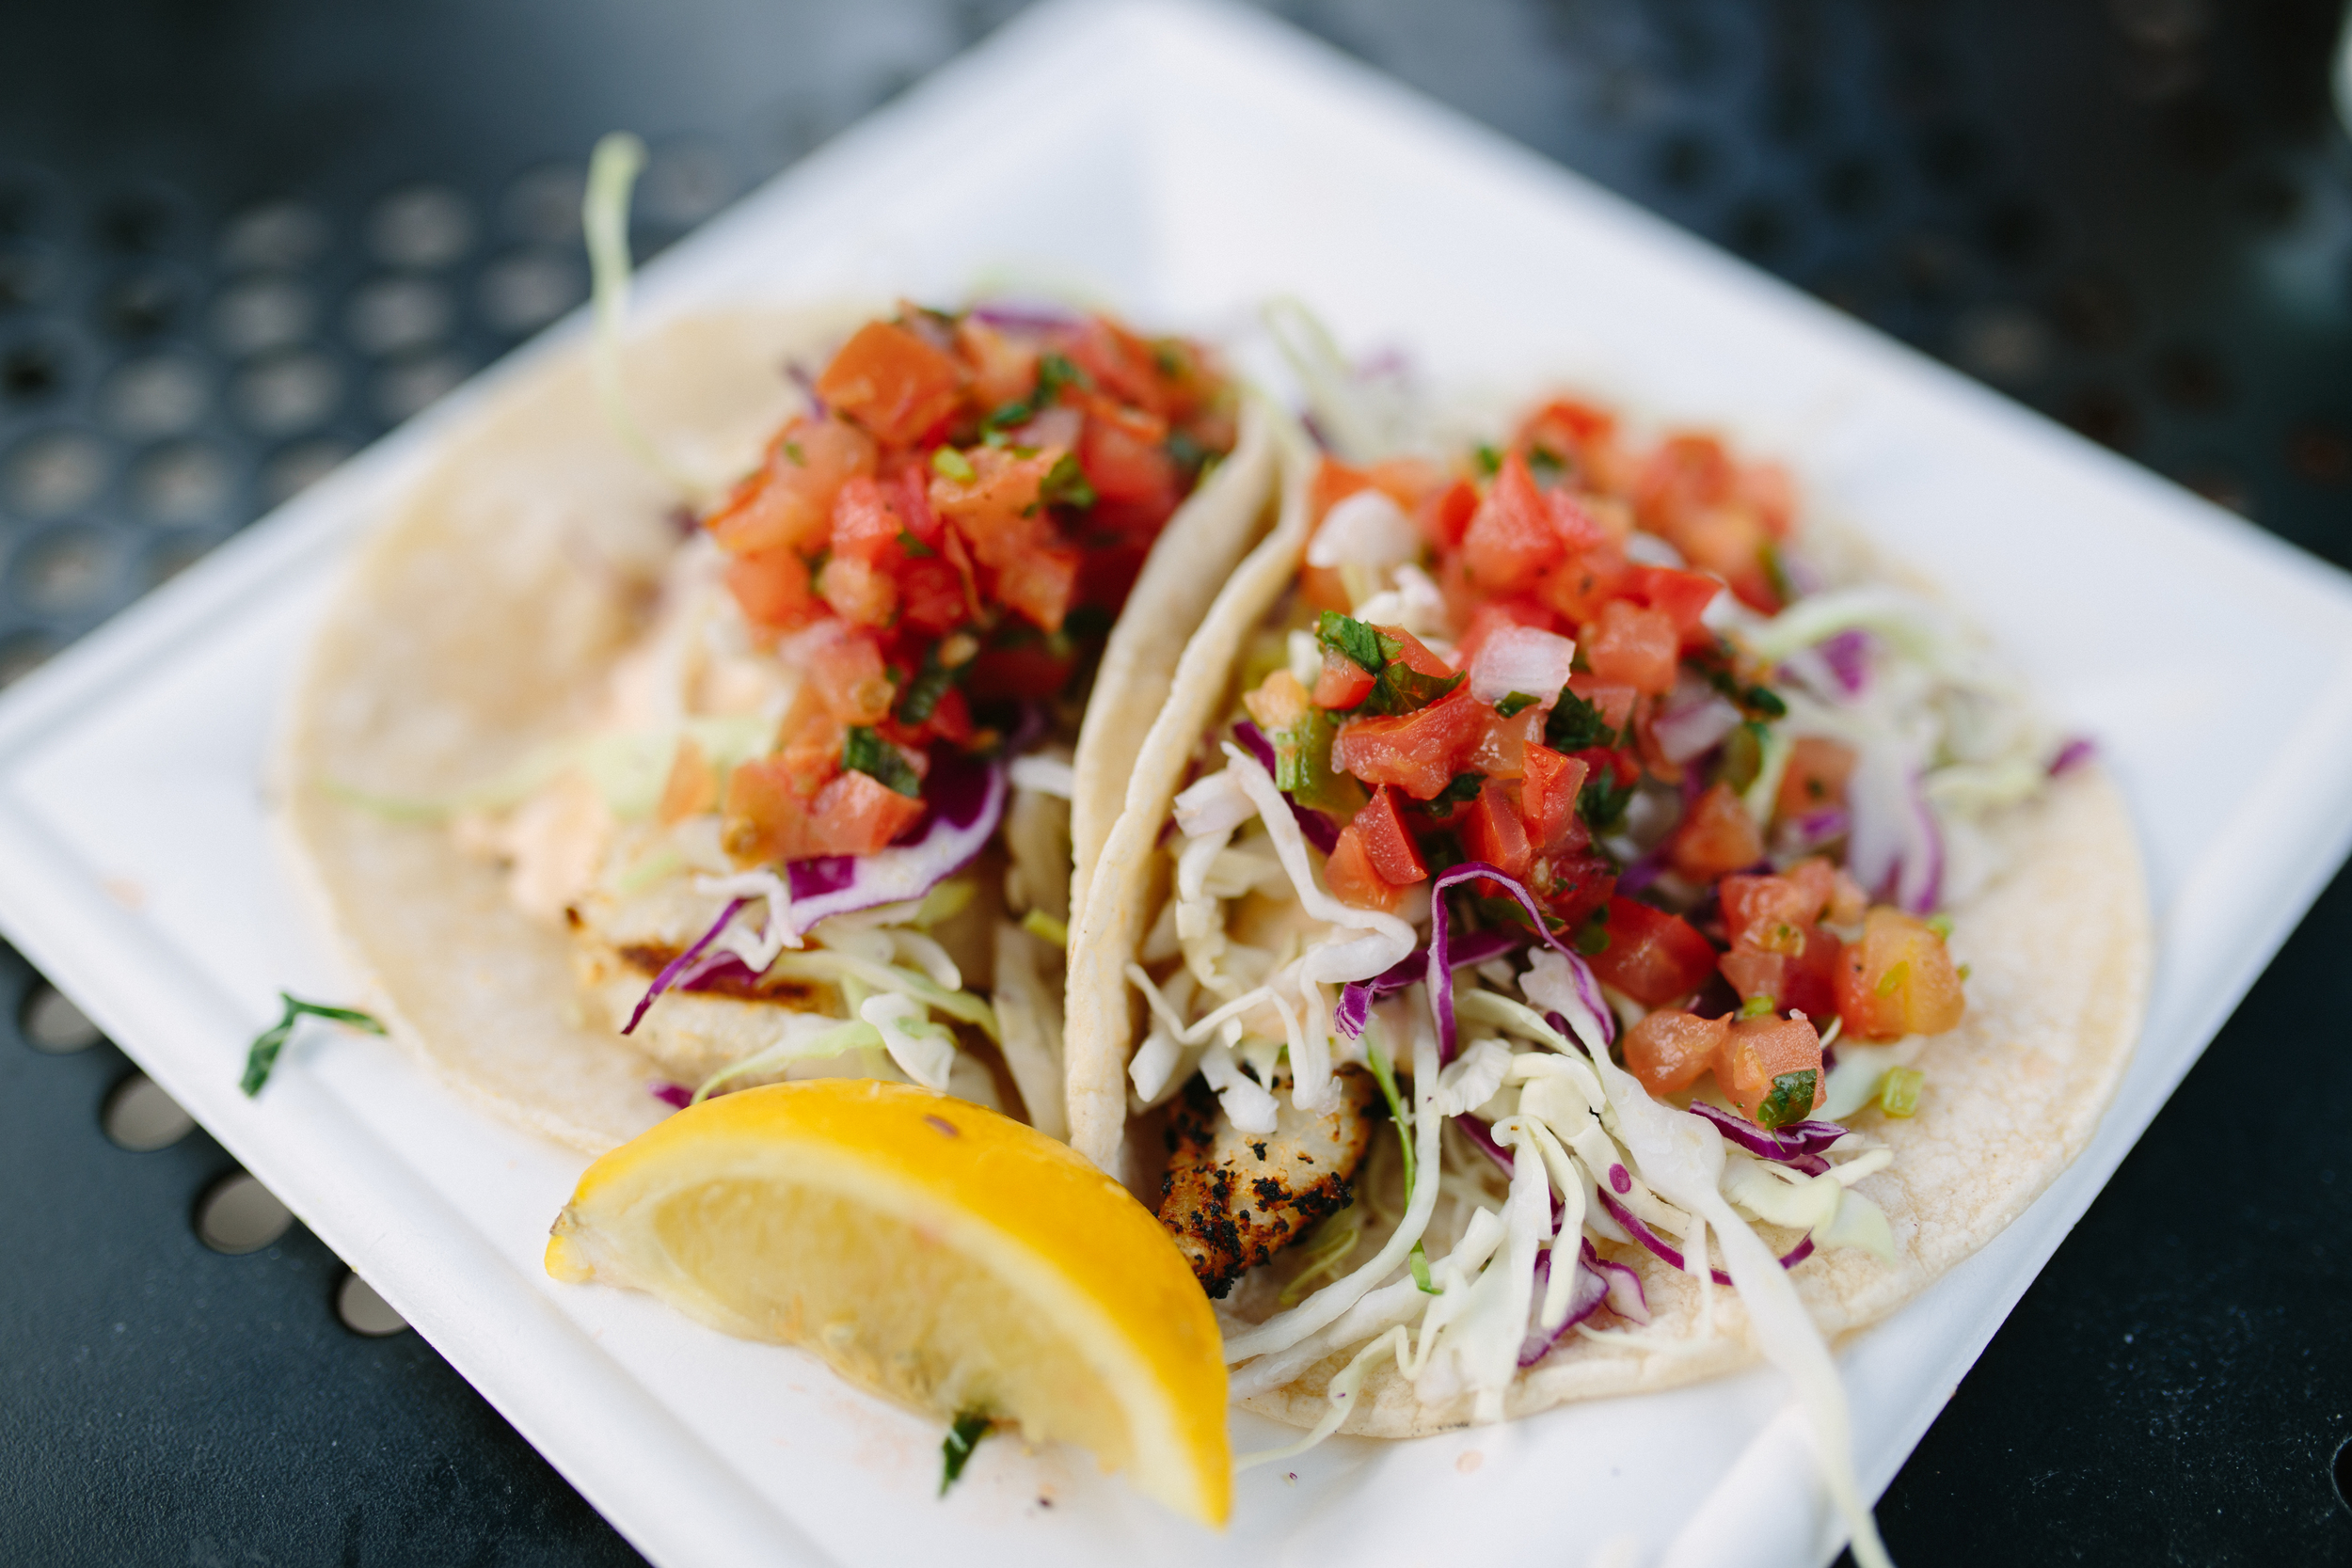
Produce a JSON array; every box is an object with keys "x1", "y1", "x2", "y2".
[{"x1": 456, "y1": 297, "x2": 1237, "y2": 1131}]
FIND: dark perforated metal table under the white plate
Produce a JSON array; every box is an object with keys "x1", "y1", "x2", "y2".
[{"x1": 0, "y1": 0, "x2": 2352, "y2": 1568}]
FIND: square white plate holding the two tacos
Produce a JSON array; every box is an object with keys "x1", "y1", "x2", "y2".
[{"x1": 0, "y1": 5, "x2": 2352, "y2": 1568}]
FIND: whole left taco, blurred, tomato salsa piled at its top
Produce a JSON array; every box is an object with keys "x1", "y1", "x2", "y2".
[{"x1": 280, "y1": 306, "x2": 1273, "y2": 1149}]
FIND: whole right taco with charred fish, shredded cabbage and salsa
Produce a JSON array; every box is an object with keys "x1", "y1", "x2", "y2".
[{"x1": 1068, "y1": 338, "x2": 2150, "y2": 1535}]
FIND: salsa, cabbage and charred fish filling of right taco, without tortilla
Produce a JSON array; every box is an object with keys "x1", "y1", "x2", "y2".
[{"x1": 1110, "y1": 402, "x2": 2089, "y2": 1495}]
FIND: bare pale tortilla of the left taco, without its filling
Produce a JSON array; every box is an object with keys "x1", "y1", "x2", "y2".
[{"x1": 276, "y1": 306, "x2": 1273, "y2": 1152}]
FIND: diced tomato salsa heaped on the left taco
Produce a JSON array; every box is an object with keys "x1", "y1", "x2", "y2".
[{"x1": 706, "y1": 308, "x2": 1235, "y2": 863}]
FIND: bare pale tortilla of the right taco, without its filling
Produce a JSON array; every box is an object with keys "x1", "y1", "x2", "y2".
[{"x1": 1066, "y1": 422, "x2": 2150, "y2": 1436}]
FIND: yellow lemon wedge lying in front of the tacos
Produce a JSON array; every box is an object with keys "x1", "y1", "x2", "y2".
[{"x1": 548, "y1": 1079, "x2": 1232, "y2": 1526}]
